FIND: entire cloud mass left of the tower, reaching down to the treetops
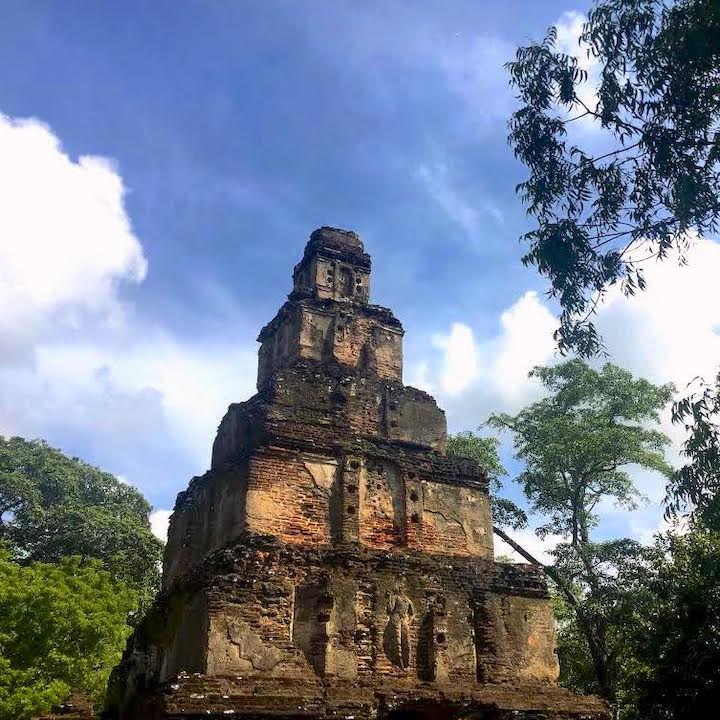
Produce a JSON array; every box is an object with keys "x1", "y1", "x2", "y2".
[{"x1": 0, "y1": 115, "x2": 256, "y2": 504}]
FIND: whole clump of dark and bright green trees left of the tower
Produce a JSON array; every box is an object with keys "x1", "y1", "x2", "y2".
[{"x1": 0, "y1": 437, "x2": 162, "y2": 720}]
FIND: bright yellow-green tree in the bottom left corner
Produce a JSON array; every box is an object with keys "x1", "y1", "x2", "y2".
[{"x1": 0, "y1": 551, "x2": 138, "y2": 720}]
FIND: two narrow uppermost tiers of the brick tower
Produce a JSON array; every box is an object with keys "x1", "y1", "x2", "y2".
[{"x1": 257, "y1": 227, "x2": 403, "y2": 389}]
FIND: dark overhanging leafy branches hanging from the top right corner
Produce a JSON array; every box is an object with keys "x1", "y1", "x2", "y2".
[{"x1": 507, "y1": 0, "x2": 720, "y2": 355}]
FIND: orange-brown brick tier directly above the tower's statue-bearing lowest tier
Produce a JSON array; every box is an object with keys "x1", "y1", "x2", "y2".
[{"x1": 164, "y1": 438, "x2": 493, "y2": 586}]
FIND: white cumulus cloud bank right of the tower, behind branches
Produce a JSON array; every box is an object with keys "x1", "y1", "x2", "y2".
[{"x1": 420, "y1": 239, "x2": 720, "y2": 541}]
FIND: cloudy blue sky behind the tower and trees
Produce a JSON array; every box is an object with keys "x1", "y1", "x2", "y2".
[{"x1": 0, "y1": 0, "x2": 720, "y2": 556}]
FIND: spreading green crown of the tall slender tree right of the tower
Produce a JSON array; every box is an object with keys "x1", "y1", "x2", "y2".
[{"x1": 488, "y1": 359, "x2": 674, "y2": 544}]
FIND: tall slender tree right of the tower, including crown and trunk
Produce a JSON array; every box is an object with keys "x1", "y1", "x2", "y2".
[{"x1": 488, "y1": 360, "x2": 673, "y2": 704}]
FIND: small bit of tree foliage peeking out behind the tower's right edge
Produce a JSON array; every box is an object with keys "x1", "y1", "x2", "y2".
[{"x1": 447, "y1": 430, "x2": 527, "y2": 529}]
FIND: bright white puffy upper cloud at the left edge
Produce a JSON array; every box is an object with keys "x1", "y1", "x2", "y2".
[{"x1": 0, "y1": 114, "x2": 147, "y2": 362}]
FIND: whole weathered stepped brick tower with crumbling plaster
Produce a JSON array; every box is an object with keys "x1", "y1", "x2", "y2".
[{"x1": 106, "y1": 228, "x2": 605, "y2": 720}]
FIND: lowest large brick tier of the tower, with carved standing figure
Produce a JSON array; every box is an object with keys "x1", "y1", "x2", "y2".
[{"x1": 107, "y1": 536, "x2": 602, "y2": 717}]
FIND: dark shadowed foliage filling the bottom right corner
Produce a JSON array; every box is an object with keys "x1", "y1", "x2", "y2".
[{"x1": 554, "y1": 526, "x2": 720, "y2": 720}]
